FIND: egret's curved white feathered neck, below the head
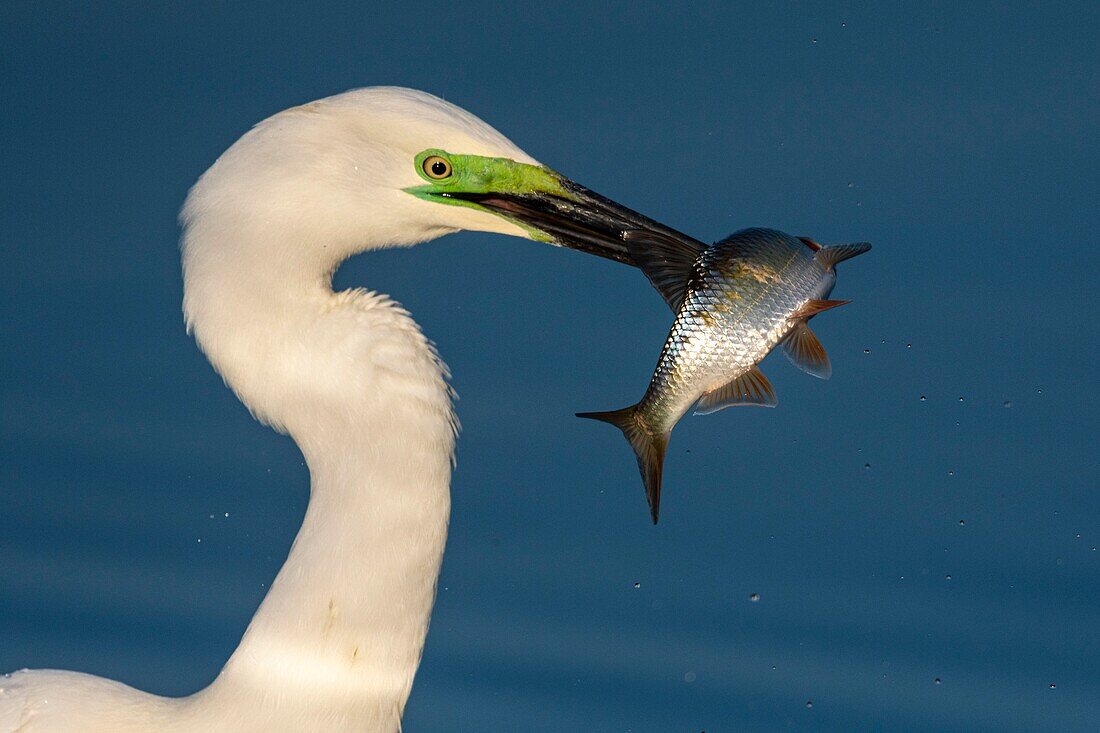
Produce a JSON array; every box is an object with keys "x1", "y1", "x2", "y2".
[{"x1": 185, "y1": 220, "x2": 455, "y2": 733}]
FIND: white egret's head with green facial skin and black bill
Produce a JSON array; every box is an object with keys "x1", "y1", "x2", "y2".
[{"x1": 183, "y1": 87, "x2": 695, "y2": 275}]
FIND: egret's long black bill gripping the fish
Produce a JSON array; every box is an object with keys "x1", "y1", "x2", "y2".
[{"x1": 437, "y1": 176, "x2": 703, "y2": 266}]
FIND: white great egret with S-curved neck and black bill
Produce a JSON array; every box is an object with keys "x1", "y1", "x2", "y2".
[{"x1": 0, "y1": 88, "x2": 699, "y2": 733}]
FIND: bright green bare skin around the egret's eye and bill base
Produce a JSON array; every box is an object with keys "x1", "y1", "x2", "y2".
[{"x1": 405, "y1": 149, "x2": 575, "y2": 242}]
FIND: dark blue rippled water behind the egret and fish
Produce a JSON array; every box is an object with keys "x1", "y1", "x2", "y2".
[{"x1": 0, "y1": 0, "x2": 1100, "y2": 733}]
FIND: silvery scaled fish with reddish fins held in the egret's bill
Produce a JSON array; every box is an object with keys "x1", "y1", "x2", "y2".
[{"x1": 576, "y1": 228, "x2": 871, "y2": 524}]
